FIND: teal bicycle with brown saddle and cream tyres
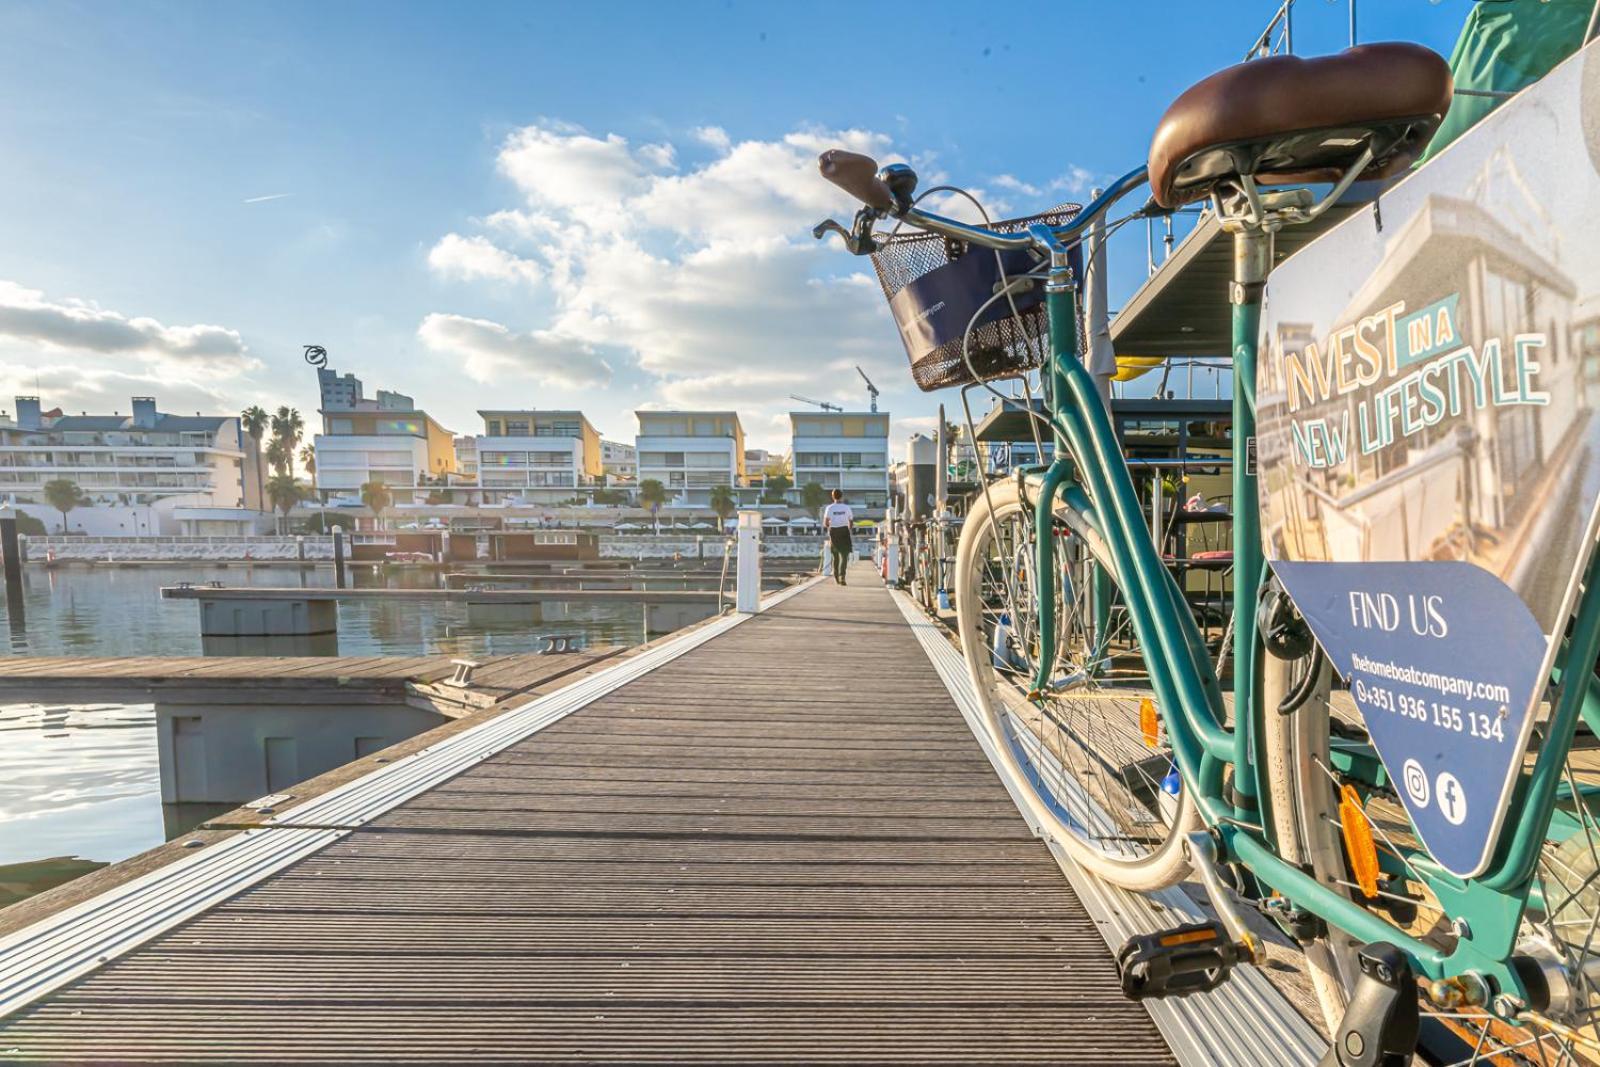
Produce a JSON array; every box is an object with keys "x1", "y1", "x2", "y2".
[{"x1": 816, "y1": 37, "x2": 1600, "y2": 1064}]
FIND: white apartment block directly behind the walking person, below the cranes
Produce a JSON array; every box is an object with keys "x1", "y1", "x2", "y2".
[{"x1": 789, "y1": 411, "x2": 890, "y2": 518}]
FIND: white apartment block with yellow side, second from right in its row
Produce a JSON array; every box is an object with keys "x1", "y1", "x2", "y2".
[{"x1": 634, "y1": 411, "x2": 746, "y2": 507}]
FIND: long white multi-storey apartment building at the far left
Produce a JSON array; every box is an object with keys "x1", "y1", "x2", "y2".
[{"x1": 0, "y1": 397, "x2": 258, "y2": 536}]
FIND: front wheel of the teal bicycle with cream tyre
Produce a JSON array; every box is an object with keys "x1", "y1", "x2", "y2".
[{"x1": 955, "y1": 483, "x2": 1198, "y2": 891}]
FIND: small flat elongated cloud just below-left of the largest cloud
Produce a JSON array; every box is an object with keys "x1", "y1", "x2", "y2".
[{"x1": 416, "y1": 312, "x2": 611, "y2": 389}]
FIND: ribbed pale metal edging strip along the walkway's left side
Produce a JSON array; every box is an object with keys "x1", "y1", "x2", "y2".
[{"x1": 0, "y1": 576, "x2": 821, "y2": 1021}]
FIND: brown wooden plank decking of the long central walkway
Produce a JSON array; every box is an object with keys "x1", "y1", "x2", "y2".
[{"x1": 0, "y1": 568, "x2": 1173, "y2": 1065}]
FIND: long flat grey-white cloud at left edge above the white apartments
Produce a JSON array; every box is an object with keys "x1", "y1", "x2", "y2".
[{"x1": 0, "y1": 282, "x2": 258, "y2": 376}]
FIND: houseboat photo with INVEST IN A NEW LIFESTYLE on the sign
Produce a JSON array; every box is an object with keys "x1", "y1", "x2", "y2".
[{"x1": 1258, "y1": 47, "x2": 1600, "y2": 632}]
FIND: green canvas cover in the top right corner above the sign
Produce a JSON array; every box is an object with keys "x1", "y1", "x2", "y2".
[{"x1": 1422, "y1": 0, "x2": 1595, "y2": 163}]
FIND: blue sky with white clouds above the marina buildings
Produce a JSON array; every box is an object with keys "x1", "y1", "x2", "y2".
[{"x1": 0, "y1": 0, "x2": 1469, "y2": 448}]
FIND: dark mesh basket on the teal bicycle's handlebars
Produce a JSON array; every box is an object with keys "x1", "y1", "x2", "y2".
[{"x1": 872, "y1": 203, "x2": 1083, "y2": 392}]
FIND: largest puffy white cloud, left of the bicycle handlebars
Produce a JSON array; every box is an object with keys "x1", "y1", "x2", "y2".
[{"x1": 424, "y1": 120, "x2": 1100, "y2": 447}]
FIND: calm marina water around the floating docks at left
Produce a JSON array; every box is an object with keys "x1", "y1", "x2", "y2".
[{"x1": 0, "y1": 563, "x2": 710, "y2": 907}]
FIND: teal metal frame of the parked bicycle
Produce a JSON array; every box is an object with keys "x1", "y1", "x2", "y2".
[{"x1": 1026, "y1": 221, "x2": 1600, "y2": 1009}]
